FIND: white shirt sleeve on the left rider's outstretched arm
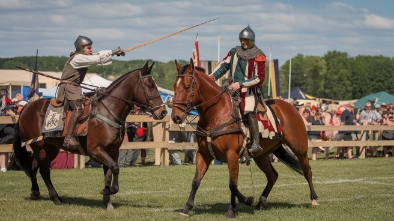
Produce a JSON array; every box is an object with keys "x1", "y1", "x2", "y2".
[{"x1": 70, "y1": 50, "x2": 112, "y2": 69}]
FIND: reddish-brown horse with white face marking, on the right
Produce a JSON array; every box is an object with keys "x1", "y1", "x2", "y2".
[{"x1": 171, "y1": 59, "x2": 318, "y2": 218}]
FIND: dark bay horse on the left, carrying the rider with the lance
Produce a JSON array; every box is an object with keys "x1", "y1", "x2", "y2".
[{"x1": 13, "y1": 62, "x2": 167, "y2": 209}]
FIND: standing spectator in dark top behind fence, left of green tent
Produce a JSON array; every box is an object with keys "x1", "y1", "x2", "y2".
[{"x1": 337, "y1": 103, "x2": 358, "y2": 159}]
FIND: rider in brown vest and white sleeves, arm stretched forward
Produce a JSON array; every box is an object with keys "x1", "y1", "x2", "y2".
[{"x1": 56, "y1": 35, "x2": 125, "y2": 149}]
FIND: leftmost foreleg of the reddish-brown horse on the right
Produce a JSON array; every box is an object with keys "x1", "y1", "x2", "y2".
[{"x1": 181, "y1": 150, "x2": 213, "y2": 216}]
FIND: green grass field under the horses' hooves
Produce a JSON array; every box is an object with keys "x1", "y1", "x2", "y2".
[{"x1": 0, "y1": 157, "x2": 394, "y2": 221}]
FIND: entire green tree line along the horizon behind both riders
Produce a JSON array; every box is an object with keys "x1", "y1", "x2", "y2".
[{"x1": 0, "y1": 51, "x2": 394, "y2": 100}]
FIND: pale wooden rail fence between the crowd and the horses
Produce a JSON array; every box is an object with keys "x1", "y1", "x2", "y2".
[{"x1": 0, "y1": 115, "x2": 394, "y2": 168}]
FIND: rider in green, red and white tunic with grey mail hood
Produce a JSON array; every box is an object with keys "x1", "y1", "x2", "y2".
[{"x1": 210, "y1": 25, "x2": 266, "y2": 153}]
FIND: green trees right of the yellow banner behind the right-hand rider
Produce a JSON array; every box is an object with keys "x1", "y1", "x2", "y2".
[{"x1": 279, "y1": 51, "x2": 394, "y2": 100}]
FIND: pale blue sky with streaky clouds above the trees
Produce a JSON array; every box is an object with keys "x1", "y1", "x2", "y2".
[{"x1": 0, "y1": 0, "x2": 394, "y2": 65}]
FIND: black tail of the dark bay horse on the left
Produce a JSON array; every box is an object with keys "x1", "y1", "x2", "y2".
[{"x1": 13, "y1": 120, "x2": 33, "y2": 177}]
